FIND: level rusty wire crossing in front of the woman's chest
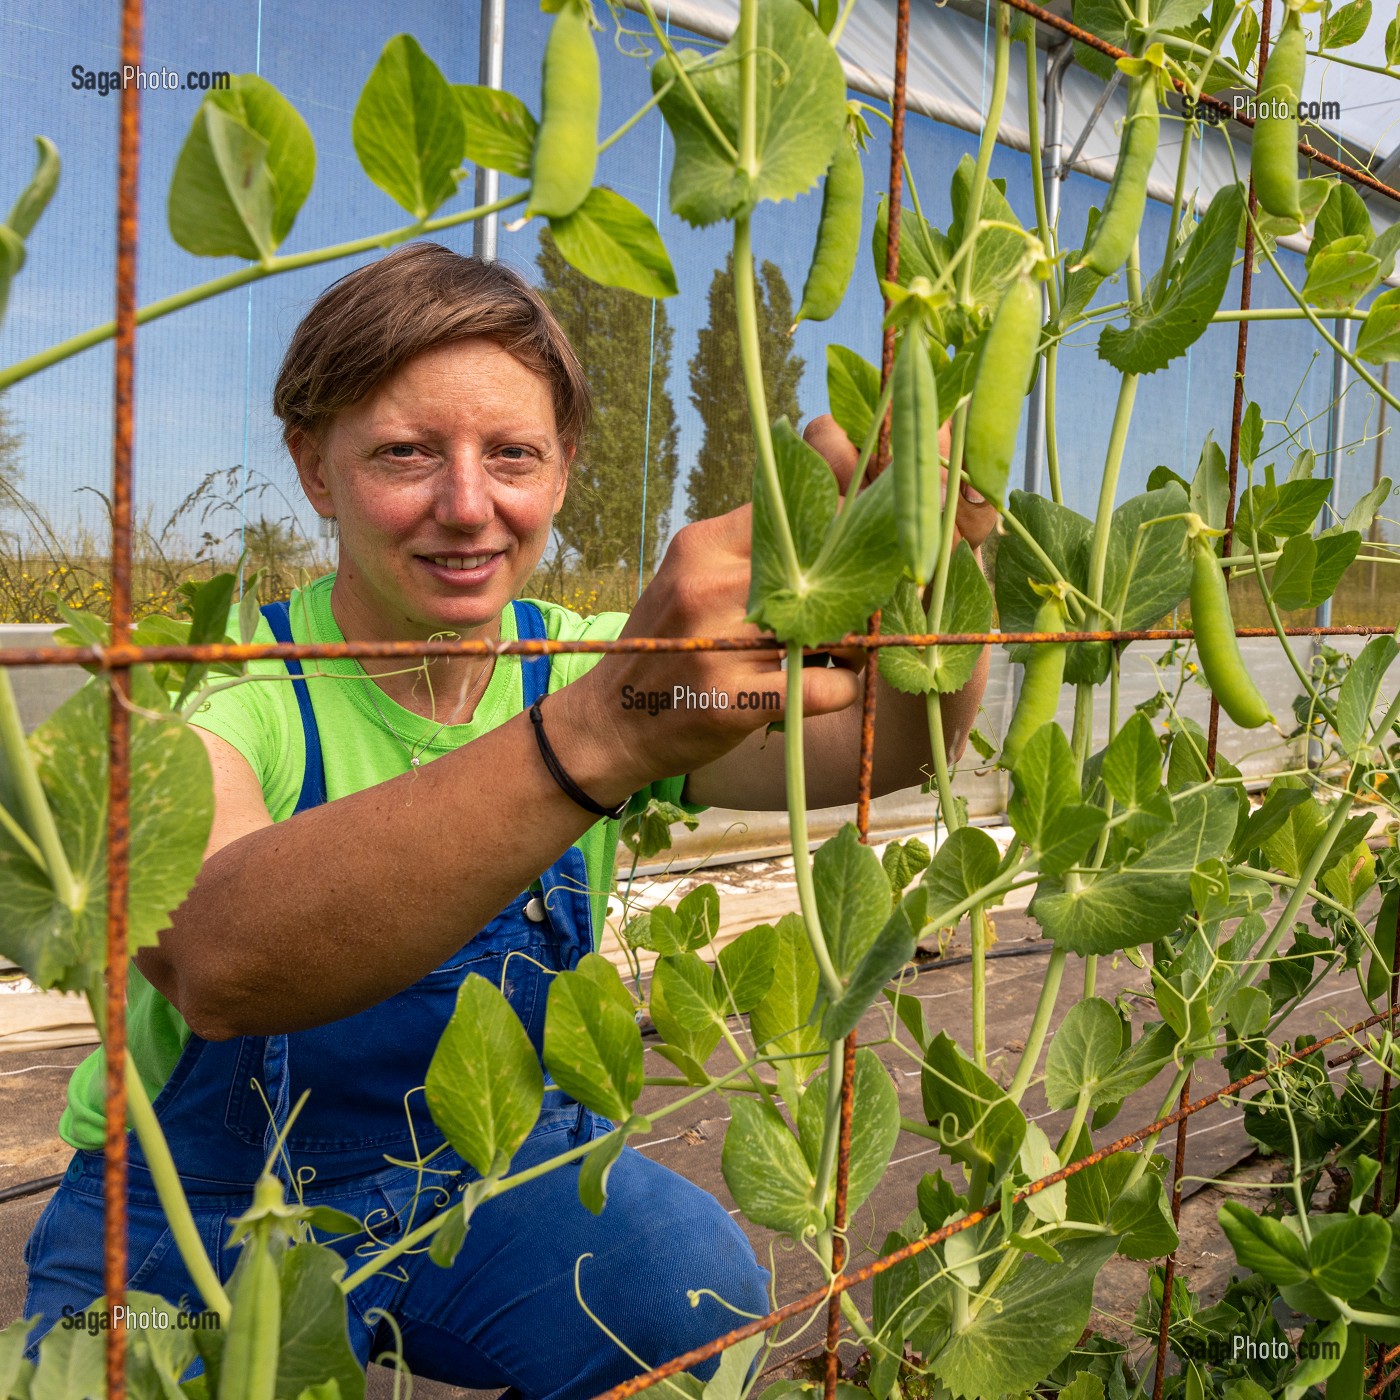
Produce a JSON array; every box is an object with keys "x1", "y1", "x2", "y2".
[{"x1": 0, "y1": 623, "x2": 1400, "y2": 671}]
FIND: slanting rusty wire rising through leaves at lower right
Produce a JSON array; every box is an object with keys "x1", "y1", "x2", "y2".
[{"x1": 594, "y1": 1005, "x2": 1400, "y2": 1400}]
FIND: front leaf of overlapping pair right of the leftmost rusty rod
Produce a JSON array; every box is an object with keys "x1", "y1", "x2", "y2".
[{"x1": 167, "y1": 97, "x2": 277, "y2": 262}]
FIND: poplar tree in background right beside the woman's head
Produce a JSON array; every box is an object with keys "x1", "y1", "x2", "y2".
[{"x1": 535, "y1": 228, "x2": 676, "y2": 574}]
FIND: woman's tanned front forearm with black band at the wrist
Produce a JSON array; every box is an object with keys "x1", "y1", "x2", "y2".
[{"x1": 137, "y1": 686, "x2": 650, "y2": 1040}]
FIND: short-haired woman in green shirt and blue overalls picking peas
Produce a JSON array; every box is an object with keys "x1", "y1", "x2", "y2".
[{"x1": 25, "y1": 244, "x2": 991, "y2": 1400}]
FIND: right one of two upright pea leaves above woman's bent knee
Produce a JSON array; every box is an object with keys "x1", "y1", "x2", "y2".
[{"x1": 545, "y1": 965, "x2": 643, "y2": 1121}]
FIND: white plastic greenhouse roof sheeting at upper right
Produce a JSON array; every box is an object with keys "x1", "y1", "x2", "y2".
[{"x1": 638, "y1": 0, "x2": 1400, "y2": 233}]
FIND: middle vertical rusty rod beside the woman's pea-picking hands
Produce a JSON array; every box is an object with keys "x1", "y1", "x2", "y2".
[{"x1": 823, "y1": 0, "x2": 909, "y2": 1400}]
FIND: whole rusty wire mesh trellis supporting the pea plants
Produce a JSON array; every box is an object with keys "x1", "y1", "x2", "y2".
[{"x1": 0, "y1": 0, "x2": 1400, "y2": 1400}]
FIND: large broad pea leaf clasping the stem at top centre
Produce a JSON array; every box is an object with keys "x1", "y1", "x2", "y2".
[{"x1": 651, "y1": 0, "x2": 846, "y2": 227}]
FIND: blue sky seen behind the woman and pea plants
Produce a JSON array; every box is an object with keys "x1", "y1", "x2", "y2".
[{"x1": 0, "y1": 0, "x2": 1400, "y2": 582}]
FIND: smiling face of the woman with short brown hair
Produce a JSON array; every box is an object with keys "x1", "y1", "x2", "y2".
[{"x1": 293, "y1": 340, "x2": 573, "y2": 638}]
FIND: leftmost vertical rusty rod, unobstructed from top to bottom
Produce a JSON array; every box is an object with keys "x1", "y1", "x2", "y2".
[{"x1": 102, "y1": 0, "x2": 143, "y2": 1400}]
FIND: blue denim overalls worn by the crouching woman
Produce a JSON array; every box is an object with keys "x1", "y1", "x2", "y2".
[{"x1": 24, "y1": 602, "x2": 767, "y2": 1400}]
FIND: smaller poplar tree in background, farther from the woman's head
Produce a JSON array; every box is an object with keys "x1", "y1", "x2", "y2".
[{"x1": 686, "y1": 255, "x2": 805, "y2": 521}]
